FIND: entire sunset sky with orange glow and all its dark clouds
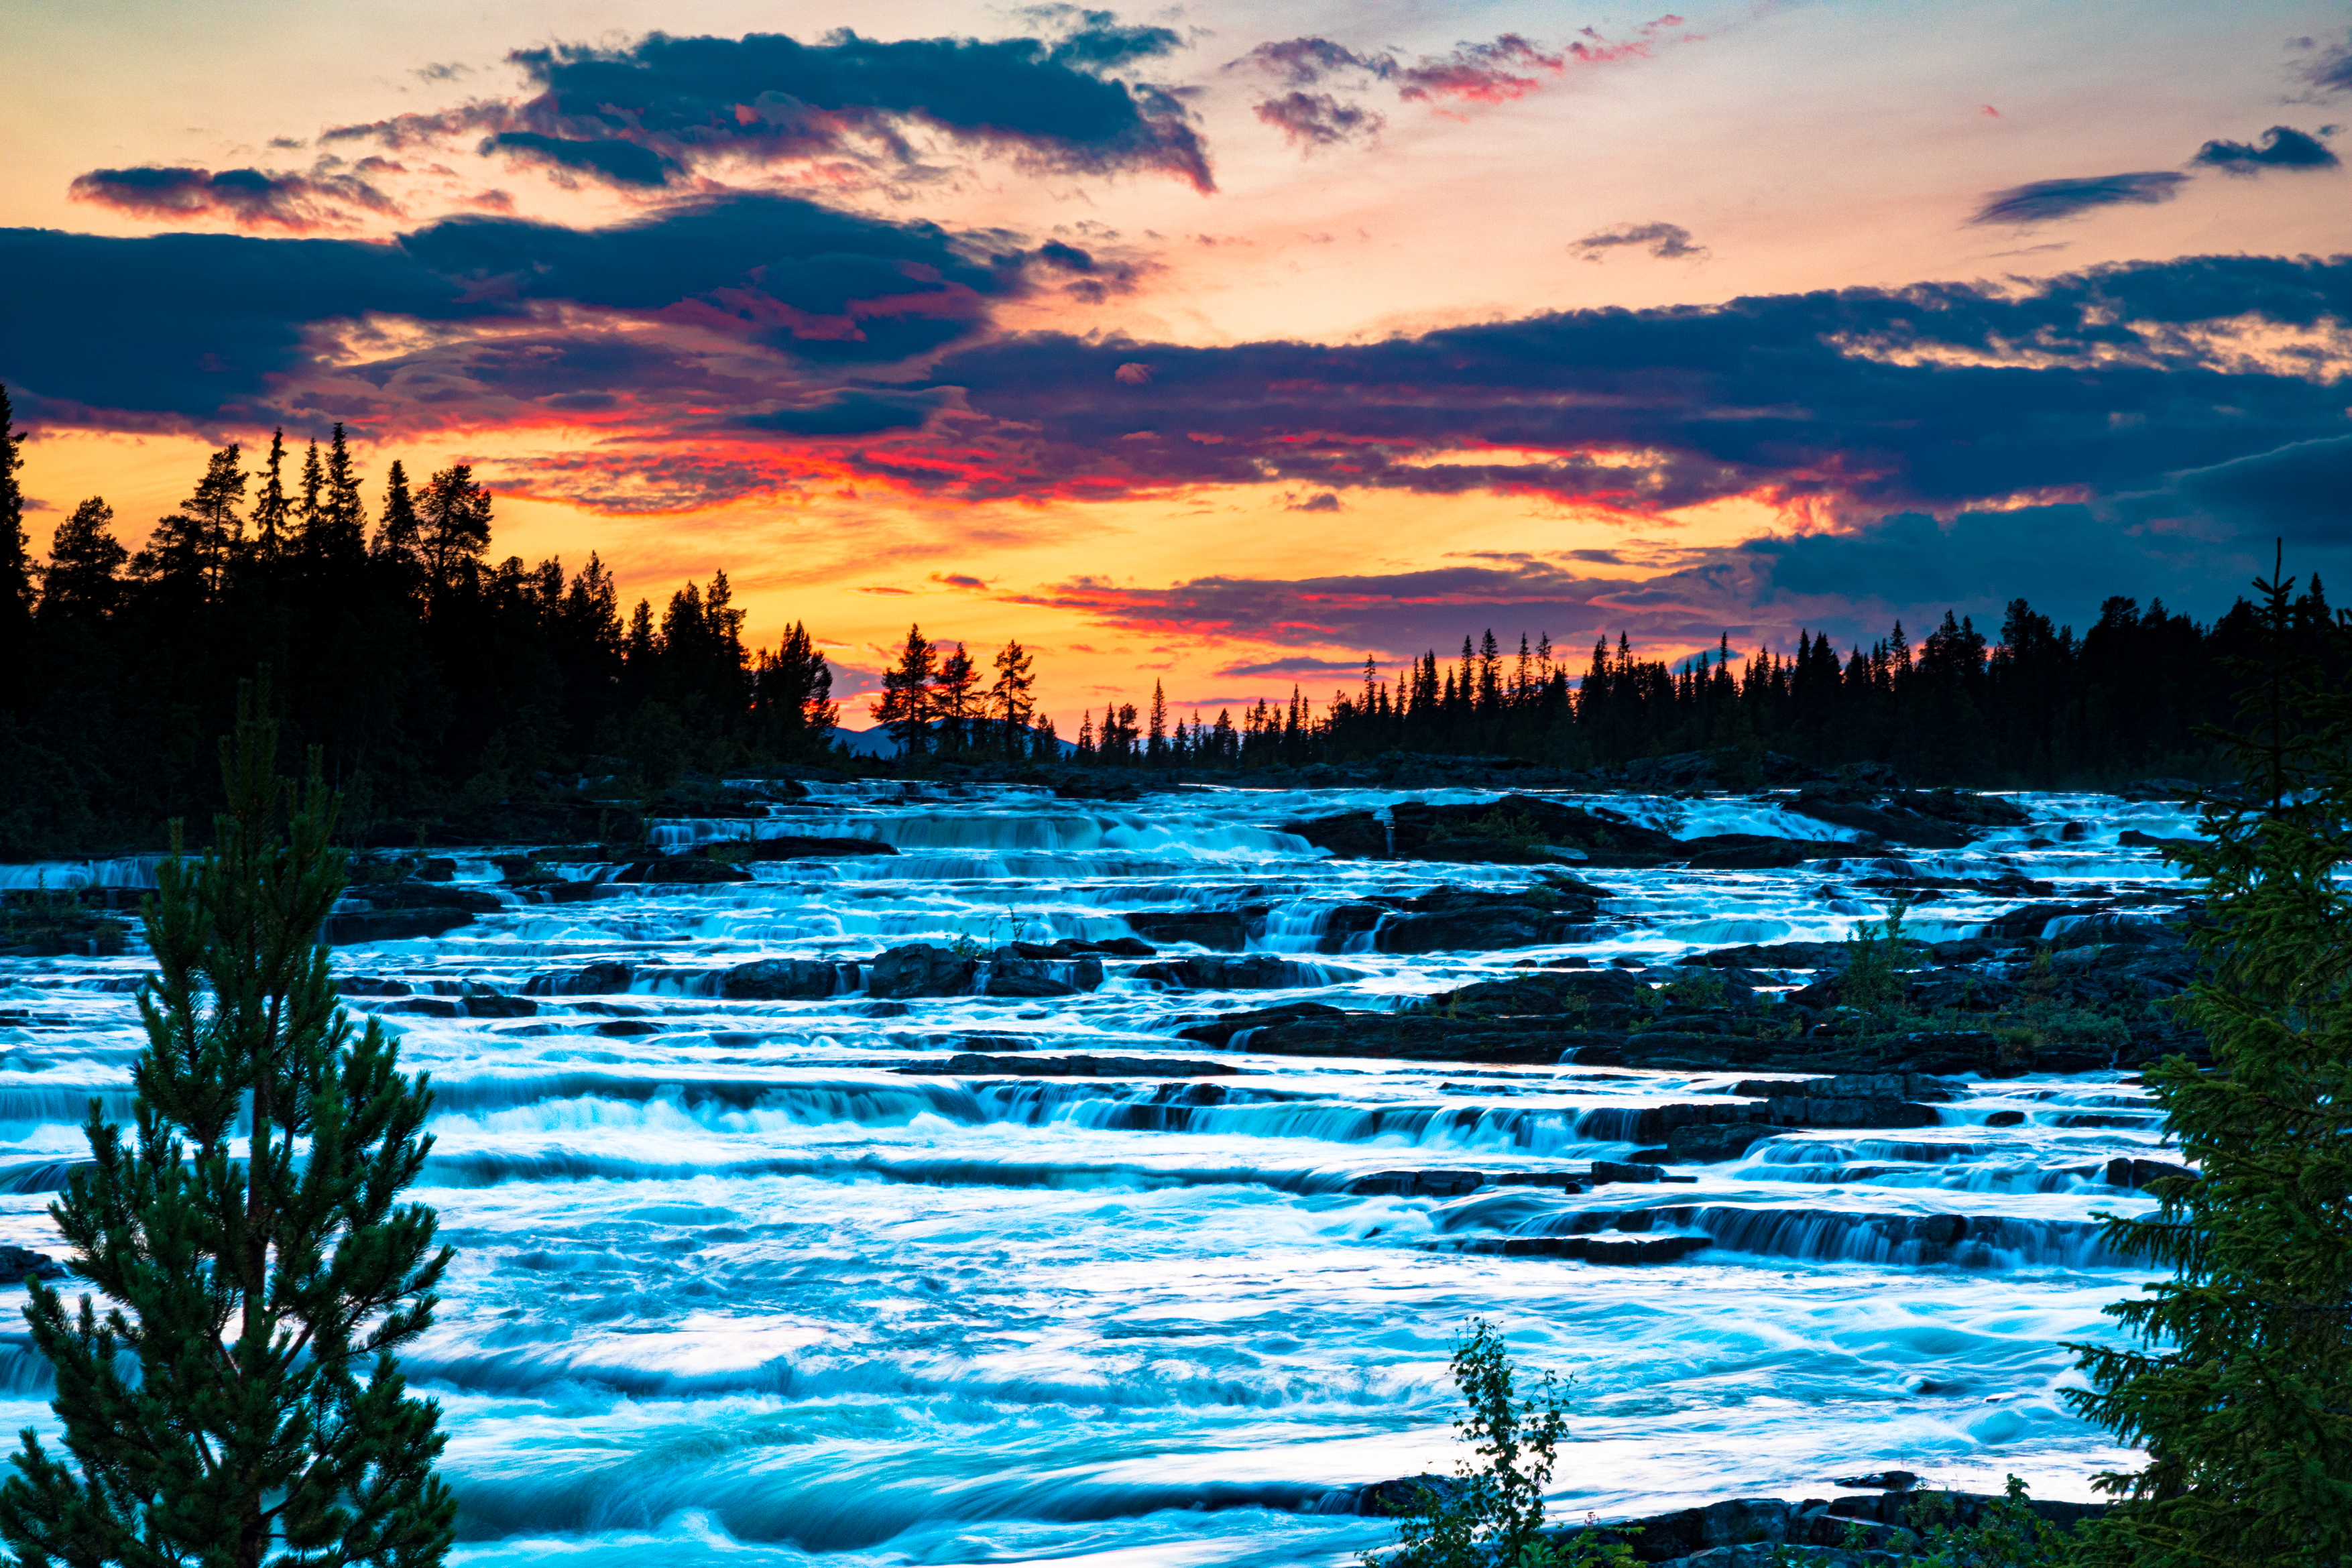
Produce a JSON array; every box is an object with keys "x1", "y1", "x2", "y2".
[{"x1": 0, "y1": 0, "x2": 2352, "y2": 733}]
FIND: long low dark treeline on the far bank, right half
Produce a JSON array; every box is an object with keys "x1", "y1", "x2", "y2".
[{"x1": 1049, "y1": 595, "x2": 2352, "y2": 788}]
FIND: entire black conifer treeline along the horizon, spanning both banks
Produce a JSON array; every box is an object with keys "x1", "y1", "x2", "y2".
[{"x1": 0, "y1": 390, "x2": 2352, "y2": 841}]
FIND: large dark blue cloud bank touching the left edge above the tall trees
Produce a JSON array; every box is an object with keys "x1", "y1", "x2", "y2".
[{"x1": 0, "y1": 195, "x2": 1049, "y2": 421}]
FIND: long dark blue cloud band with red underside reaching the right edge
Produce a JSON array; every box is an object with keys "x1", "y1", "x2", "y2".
[{"x1": 879, "y1": 256, "x2": 2352, "y2": 517}]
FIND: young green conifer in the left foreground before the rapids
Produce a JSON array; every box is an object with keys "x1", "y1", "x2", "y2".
[{"x1": 0, "y1": 688, "x2": 457, "y2": 1568}]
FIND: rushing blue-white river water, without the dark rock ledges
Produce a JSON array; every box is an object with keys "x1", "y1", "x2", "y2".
[{"x1": 0, "y1": 785, "x2": 2187, "y2": 1568}]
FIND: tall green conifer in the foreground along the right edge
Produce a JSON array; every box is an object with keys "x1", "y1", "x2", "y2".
[{"x1": 2074, "y1": 552, "x2": 2352, "y2": 1568}]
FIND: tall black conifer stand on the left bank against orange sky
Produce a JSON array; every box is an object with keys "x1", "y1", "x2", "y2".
[{"x1": 0, "y1": 390, "x2": 837, "y2": 855}]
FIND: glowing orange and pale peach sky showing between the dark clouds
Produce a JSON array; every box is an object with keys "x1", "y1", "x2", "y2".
[{"x1": 0, "y1": 0, "x2": 2352, "y2": 729}]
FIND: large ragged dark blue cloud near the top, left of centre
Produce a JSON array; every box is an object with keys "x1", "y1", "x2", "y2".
[{"x1": 327, "y1": 25, "x2": 1214, "y2": 190}]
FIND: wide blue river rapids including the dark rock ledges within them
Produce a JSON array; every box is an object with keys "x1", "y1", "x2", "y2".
[{"x1": 0, "y1": 774, "x2": 2199, "y2": 1568}]
